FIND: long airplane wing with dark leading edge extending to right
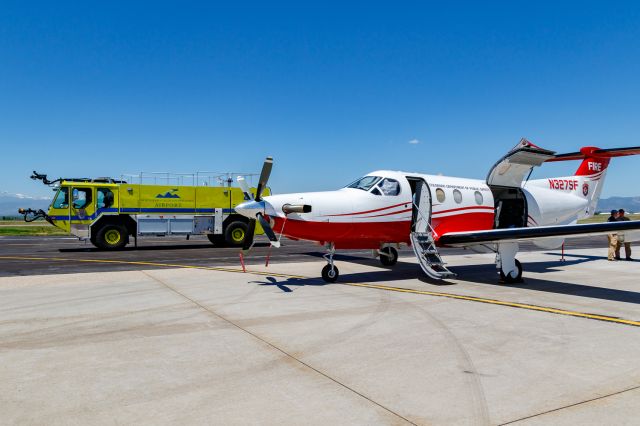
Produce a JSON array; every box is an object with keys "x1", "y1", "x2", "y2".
[{"x1": 437, "y1": 220, "x2": 640, "y2": 247}]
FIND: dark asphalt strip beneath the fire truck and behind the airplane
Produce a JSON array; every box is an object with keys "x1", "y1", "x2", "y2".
[{"x1": 0, "y1": 236, "x2": 606, "y2": 276}]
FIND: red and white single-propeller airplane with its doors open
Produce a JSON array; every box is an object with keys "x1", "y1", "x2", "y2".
[{"x1": 235, "y1": 139, "x2": 640, "y2": 283}]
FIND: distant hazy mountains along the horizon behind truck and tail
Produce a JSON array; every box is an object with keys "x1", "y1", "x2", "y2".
[{"x1": 0, "y1": 191, "x2": 640, "y2": 216}]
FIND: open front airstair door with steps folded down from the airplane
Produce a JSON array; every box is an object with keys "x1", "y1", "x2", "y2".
[{"x1": 410, "y1": 180, "x2": 456, "y2": 280}]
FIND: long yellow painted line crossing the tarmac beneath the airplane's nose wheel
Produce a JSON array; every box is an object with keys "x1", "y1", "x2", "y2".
[{"x1": 0, "y1": 256, "x2": 640, "y2": 327}]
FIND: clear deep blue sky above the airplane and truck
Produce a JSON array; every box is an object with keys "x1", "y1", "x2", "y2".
[{"x1": 0, "y1": 1, "x2": 640, "y2": 196}]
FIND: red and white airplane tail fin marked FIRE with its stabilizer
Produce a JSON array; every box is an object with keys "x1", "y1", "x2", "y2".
[{"x1": 547, "y1": 146, "x2": 640, "y2": 219}]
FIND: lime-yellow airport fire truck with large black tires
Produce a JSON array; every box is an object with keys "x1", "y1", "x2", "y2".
[{"x1": 19, "y1": 172, "x2": 270, "y2": 250}]
